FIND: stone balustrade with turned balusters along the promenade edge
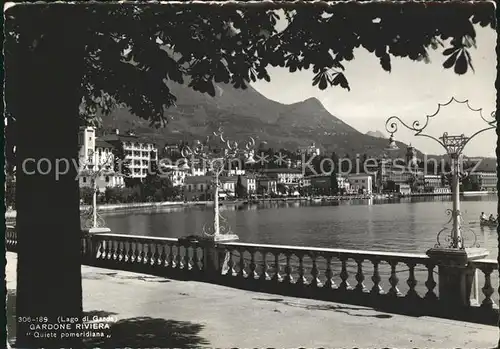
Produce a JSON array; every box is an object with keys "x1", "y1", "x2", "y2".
[{"x1": 6, "y1": 229, "x2": 498, "y2": 322}]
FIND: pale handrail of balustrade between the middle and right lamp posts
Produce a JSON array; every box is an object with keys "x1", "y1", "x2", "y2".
[{"x1": 219, "y1": 242, "x2": 429, "y2": 260}]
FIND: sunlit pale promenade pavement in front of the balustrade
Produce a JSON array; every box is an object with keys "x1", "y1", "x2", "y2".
[{"x1": 6, "y1": 252, "x2": 498, "y2": 348}]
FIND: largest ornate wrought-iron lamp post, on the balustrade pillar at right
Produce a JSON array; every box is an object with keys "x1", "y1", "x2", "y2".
[{"x1": 386, "y1": 98, "x2": 496, "y2": 250}]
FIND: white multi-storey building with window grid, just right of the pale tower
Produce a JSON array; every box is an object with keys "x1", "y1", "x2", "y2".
[{"x1": 99, "y1": 129, "x2": 158, "y2": 180}]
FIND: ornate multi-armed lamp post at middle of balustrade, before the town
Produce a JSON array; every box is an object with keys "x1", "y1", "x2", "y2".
[{"x1": 181, "y1": 128, "x2": 255, "y2": 241}]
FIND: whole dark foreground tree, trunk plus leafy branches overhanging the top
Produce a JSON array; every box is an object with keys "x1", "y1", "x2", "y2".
[{"x1": 4, "y1": 2, "x2": 495, "y2": 347}]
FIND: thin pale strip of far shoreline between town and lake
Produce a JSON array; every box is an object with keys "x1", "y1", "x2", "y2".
[{"x1": 5, "y1": 193, "x2": 488, "y2": 220}]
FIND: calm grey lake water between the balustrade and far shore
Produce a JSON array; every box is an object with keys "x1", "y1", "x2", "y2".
[{"x1": 105, "y1": 195, "x2": 497, "y2": 258}]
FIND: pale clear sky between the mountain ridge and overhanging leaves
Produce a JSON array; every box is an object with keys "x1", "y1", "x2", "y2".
[{"x1": 252, "y1": 22, "x2": 496, "y2": 157}]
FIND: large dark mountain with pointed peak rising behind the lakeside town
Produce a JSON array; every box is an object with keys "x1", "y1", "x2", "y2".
[{"x1": 99, "y1": 83, "x2": 412, "y2": 156}]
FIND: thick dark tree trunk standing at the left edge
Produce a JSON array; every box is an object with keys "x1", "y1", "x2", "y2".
[{"x1": 7, "y1": 6, "x2": 85, "y2": 348}]
